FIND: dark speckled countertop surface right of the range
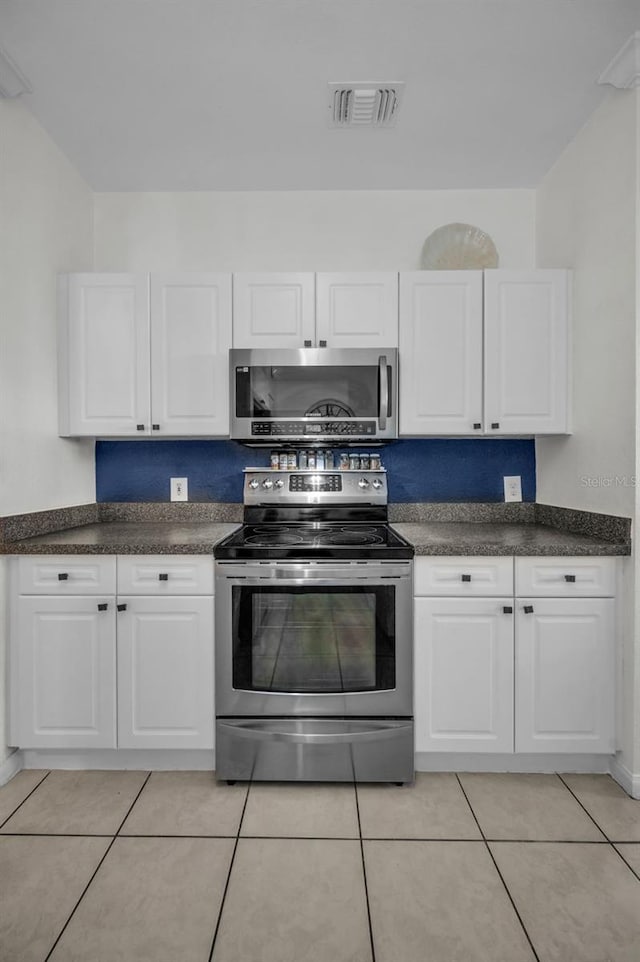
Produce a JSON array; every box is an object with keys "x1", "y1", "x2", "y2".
[{"x1": 392, "y1": 521, "x2": 631, "y2": 557}]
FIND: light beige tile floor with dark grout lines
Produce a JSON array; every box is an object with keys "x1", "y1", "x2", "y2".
[{"x1": 0, "y1": 771, "x2": 640, "y2": 962}]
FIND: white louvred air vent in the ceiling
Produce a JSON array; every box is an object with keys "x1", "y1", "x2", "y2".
[{"x1": 329, "y1": 81, "x2": 404, "y2": 127}]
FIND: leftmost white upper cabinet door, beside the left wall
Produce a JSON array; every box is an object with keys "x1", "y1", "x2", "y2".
[{"x1": 58, "y1": 274, "x2": 151, "y2": 437}]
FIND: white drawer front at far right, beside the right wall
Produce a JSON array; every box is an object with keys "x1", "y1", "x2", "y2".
[{"x1": 516, "y1": 557, "x2": 616, "y2": 598}]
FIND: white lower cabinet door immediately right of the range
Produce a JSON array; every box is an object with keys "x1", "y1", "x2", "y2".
[{"x1": 414, "y1": 598, "x2": 513, "y2": 752}]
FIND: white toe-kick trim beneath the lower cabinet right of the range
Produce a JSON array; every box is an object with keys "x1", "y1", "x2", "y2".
[{"x1": 415, "y1": 752, "x2": 612, "y2": 774}]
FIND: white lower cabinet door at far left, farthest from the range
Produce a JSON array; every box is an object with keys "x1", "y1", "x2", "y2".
[{"x1": 12, "y1": 595, "x2": 116, "y2": 748}]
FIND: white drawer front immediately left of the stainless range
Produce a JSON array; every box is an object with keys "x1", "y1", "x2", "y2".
[{"x1": 118, "y1": 555, "x2": 213, "y2": 595}]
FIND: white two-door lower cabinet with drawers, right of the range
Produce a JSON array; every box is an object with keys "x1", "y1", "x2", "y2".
[{"x1": 414, "y1": 557, "x2": 616, "y2": 754}]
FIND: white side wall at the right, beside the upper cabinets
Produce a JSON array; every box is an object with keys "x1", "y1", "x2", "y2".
[{"x1": 536, "y1": 90, "x2": 640, "y2": 776}]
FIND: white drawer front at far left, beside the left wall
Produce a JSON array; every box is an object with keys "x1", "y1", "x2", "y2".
[{"x1": 18, "y1": 554, "x2": 116, "y2": 595}]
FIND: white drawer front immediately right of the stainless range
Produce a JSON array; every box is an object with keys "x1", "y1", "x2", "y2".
[{"x1": 414, "y1": 557, "x2": 513, "y2": 597}]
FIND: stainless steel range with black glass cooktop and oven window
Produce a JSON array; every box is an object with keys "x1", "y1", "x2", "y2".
[{"x1": 215, "y1": 469, "x2": 413, "y2": 782}]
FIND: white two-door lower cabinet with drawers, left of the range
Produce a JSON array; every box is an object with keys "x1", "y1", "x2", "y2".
[{"x1": 10, "y1": 555, "x2": 214, "y2": 749}]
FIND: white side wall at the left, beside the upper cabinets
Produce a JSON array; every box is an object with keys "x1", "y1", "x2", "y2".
[{"x1": 0, "y1": 100, "x2": 95, "y2": 765}]
